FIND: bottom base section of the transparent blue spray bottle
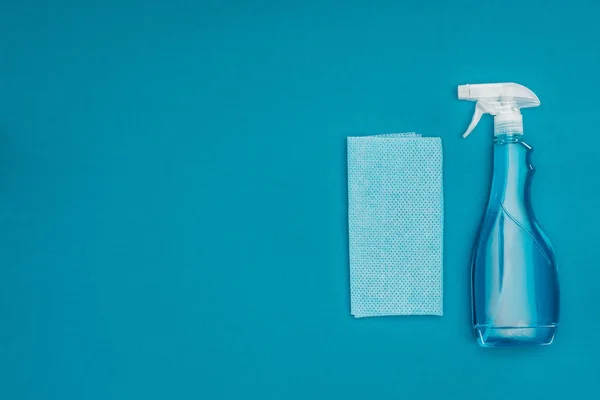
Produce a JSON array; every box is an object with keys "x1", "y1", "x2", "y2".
[{"x1": 475, "y1": 324, "x2": 557, "y2": 347}]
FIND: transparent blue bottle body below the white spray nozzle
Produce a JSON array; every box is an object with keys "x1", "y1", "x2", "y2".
[{"x1": 472, "y1": 135, "x2": 560, "y2": 347}]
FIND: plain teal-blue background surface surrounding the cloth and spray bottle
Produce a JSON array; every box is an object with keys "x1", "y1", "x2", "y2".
[{"x1": 0, "y1": 0, "x2": 600, "y2": 400}]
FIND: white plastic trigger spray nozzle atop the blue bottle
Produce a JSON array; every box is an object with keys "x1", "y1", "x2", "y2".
[{"x1": 458, "y1": 83, "x2": 540, "y2": 138}]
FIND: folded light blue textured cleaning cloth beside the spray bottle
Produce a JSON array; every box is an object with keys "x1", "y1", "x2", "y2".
[{"x1": 348, "y1": 133, "x2": 444, "y2": 318}]
